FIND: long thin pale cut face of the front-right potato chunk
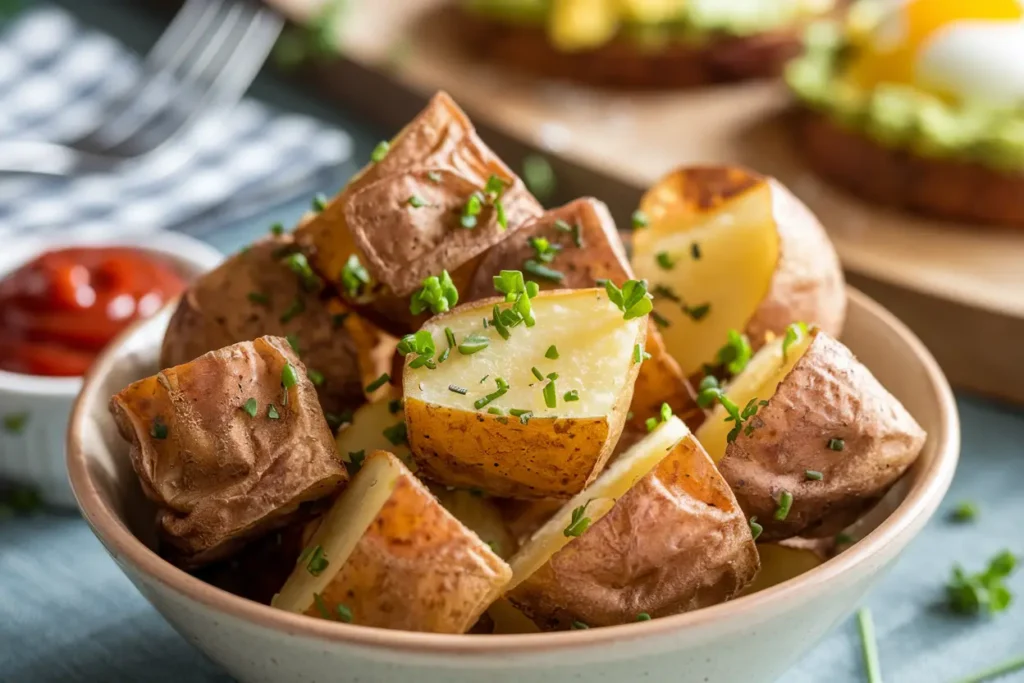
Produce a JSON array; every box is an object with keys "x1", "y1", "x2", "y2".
[{"x1": 506, "y1": 416, "x2": 690, "y2": 591}]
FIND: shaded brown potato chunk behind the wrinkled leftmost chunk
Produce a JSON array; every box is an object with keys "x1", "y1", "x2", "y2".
[{"x1": 160, "y1": 236, "x2": 378, "y2": 415}]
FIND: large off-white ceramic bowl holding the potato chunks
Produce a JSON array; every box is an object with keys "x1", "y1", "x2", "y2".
[{"x1": 68, "y1": 290, "x2": 959, "y2": 683}]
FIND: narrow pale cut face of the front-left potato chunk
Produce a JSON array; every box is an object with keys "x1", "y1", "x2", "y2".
[{"x1": 271, "y1": 458, "x2": 401, "y2": 613}]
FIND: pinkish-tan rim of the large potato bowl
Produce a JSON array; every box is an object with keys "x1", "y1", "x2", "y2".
[{"x1": 68, "y1": 286, "x2": 961, "y2": 655}]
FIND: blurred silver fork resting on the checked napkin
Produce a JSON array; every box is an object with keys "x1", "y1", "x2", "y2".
[{"x1": 0, "y1": 0, "x2": 284, "y2": 175}]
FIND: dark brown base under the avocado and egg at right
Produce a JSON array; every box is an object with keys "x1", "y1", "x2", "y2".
[{"x1": 794, "y1": 109, "x2": 1024, "y2": 227}]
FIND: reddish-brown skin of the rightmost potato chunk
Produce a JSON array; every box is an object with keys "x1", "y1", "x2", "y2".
[{"x1": 718, "y1": 331, "x2": 926, "y2": 542}]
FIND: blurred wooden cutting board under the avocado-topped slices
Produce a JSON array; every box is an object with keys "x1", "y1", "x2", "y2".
[{"x1": 267, "y1": 0, "x2": 1024, "y2": 402}]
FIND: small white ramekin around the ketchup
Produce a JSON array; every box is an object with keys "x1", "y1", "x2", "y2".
[{"x1": 0, "y1": 232, "x2": 223, "y2": 507}]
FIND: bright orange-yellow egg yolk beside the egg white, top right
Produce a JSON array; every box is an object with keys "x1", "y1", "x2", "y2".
[{"x1": 847, "y1": 0, "x2": 1024, "y2": 88}]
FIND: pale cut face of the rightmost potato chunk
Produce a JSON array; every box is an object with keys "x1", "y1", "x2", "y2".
[{"x1": 696, "y1": 327, "x2": 814, "y2": 463}]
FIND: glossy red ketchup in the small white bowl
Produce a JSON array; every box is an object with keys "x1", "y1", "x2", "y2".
[{"x1": 0, "y1": 247, "x2": 185, "y2": 377}]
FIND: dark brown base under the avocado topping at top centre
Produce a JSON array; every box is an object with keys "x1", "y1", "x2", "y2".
[{"x1": 454, "y1": 11, "x2": 803, "y2": 89}]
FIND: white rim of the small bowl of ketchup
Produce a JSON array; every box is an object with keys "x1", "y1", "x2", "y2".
[{"x1": 0, "y1": 230, "x2": 224, "y2": 398}]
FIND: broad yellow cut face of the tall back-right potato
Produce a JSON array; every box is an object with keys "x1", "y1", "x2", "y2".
[{"x1": 633, "y1": 184, "x2": 779, "y2": 376}]
